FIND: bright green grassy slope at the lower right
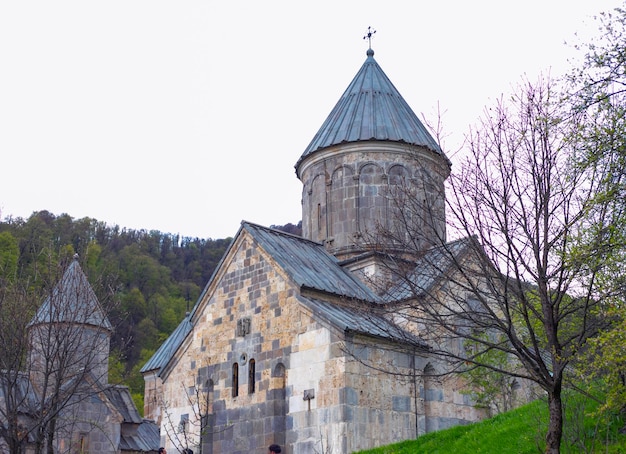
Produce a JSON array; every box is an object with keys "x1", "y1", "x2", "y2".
[{"x1": 360, "y1": 396, "x2": 626, "y2": 454}]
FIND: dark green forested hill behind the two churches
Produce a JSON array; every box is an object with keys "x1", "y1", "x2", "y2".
[{"x1": 0, "y1": 211, "x2": 301, "y2": 400}]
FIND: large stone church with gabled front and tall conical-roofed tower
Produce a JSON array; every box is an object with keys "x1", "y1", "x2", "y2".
[{"x1": 142, "y1": 44, "x2": 484, "y2": 454}]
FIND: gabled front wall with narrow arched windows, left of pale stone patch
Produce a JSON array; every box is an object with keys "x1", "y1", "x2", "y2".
[{"x1": 161, "y1": 235, "x2": 310, "y2": 454}]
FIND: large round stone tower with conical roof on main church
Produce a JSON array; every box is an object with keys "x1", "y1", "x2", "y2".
[{"x1": 295, "y1": 40, "x2": 450, "y2": 288}]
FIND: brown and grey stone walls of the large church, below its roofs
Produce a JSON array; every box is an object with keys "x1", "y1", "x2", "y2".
[{"x1": 145, "y1": 226, "x2": 482, "y2": 454}]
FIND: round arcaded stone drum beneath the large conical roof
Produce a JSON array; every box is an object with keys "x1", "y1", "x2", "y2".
[{"x1": 298, "y1": 141, "x2": 450, "y2": 259}]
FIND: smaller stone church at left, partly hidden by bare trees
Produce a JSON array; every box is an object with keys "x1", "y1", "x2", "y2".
[{"x1": 0, "y1": 255, "x2": 159, "y2": 454}]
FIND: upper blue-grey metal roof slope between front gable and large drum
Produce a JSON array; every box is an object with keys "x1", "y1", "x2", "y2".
[{"x1": 242, "y1": 222, "x2": 378, "y2": 302}]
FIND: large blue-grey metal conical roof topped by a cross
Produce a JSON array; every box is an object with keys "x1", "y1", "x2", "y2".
[{"x1": 296, "y1": 49, "x2": 443, "y2": 167}]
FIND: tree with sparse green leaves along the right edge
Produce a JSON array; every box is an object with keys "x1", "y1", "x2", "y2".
[{"x1": 568, "y1": 3, "x2": 626, "y2": 422}]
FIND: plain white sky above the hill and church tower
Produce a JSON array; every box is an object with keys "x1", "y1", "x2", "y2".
[{"x1": 0, "y1": 0, "x2": 621, "y2": 238}]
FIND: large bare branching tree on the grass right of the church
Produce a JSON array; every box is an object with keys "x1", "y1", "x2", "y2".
[{"x1": 360, "y1": 77, "x2": 610, "y2": 453}]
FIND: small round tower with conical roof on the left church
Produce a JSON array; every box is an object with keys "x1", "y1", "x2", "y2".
[{"x1": 28, "y1": 255, "x2": 112, "y2": 391}]
